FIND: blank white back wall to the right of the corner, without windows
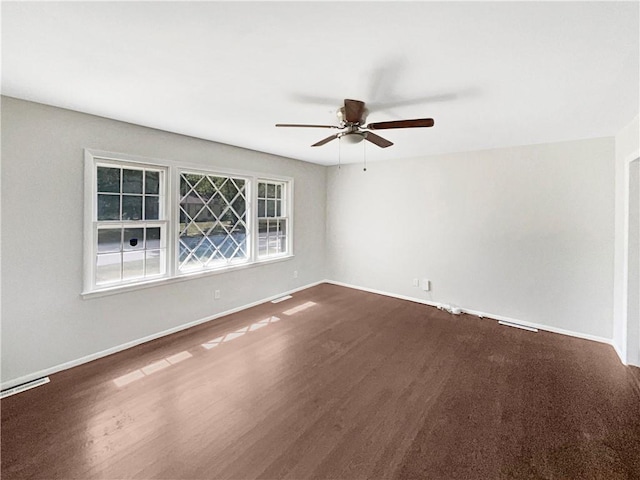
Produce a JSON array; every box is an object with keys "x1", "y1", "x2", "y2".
[{"x1": 327, "y1": 138, "x2": 615, "y2": 339}]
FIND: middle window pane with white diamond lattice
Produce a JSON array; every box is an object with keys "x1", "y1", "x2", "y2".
[{"x1": 178, "y1": 173, "x2": 249, "y2": 271}]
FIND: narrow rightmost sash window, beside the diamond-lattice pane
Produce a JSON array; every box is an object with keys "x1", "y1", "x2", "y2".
[{"x1": 258, "y1": 180, "x2": 288, "y2": 258}]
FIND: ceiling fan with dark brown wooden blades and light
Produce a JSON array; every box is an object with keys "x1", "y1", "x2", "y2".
[{"x1": 276, "y1": 99, "x2": 434, "y2": 148}]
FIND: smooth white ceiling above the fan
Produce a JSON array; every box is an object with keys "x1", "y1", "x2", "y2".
[{"x1": 2, "y1": 2, "x2": 640, "y2": 165}]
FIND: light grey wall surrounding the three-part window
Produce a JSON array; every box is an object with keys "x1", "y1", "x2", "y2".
[{"x1": 2, "y1": 97, "x2": 326, "y2": 388}]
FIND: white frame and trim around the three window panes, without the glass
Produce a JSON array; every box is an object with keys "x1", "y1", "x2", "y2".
[{"x1": 81, "y1": 149, "x2": 294, "y2": 298}]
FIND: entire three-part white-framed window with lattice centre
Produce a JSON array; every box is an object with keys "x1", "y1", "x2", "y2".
[{"x1": 84, "y1": 150, "x2": 293, "y2": 293}]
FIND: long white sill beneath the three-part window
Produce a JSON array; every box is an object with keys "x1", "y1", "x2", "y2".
[{"x1": 80, "y1": 254, "x2": 294, "y2": 300}]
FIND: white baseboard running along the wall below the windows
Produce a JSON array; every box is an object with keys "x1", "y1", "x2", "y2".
[{"x1": 0, "y1": 280, "x2": 325, "y2": 390}]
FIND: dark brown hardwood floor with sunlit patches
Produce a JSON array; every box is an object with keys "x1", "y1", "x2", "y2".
[{"x1": 1, "y1": 285, "x2": 640, "y2": 480}]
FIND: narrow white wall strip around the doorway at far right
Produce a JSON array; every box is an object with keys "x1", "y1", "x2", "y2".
[{"x1": 613, "y1": 116, "x2": 640, "y2": 365}]
